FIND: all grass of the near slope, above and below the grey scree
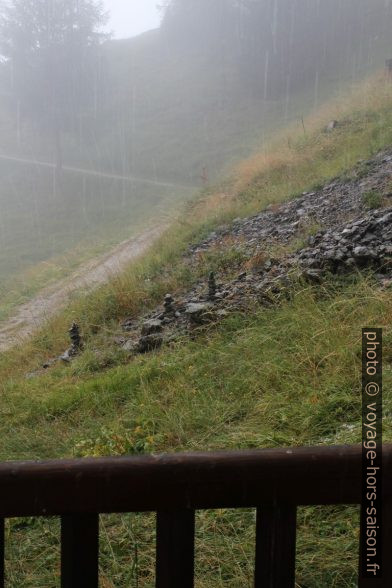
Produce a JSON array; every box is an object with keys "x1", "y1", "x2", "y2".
[{"x1": 0, "y1": 74, "x2": 392, "y2": 588}]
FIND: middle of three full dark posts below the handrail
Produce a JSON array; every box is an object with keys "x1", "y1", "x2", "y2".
[{"x1": 156, "y1": 510, "x2": 195, "y2": 588}]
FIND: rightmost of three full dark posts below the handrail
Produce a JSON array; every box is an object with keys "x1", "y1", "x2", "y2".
[{"x1": 254, "y1": 505, "x2": 297, "y2": 588}]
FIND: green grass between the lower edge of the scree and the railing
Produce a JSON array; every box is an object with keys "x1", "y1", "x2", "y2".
[{"x1": 0, "y1": 278, "x2": 392, "y2": 588}]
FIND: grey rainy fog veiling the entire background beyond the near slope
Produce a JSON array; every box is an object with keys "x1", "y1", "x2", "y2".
[{"x1": 0, "y1": 0, "x2": 392, "y2": 312}]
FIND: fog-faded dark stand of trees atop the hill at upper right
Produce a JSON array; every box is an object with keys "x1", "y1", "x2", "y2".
[{"x1": 163, "y1": 0, "x2": 392, "y2": 100}]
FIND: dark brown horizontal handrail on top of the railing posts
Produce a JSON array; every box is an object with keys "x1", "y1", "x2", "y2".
[{"x1": 0, "y1": 446, "x2": 376, "y2": 517}]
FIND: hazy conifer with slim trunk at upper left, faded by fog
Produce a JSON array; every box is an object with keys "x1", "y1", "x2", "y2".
[{"x1": 0, "y1": 0, "x2": 107, "y2": 169}]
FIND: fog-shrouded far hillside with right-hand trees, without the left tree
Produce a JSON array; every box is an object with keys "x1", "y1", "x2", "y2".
[{"x1": 0, "y1": 0, "x2": 392, "y2": 300}]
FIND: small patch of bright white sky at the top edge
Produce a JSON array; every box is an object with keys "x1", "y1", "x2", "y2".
[{"x1": 104, "y1": 0, "x2": 160, "y2": 39}]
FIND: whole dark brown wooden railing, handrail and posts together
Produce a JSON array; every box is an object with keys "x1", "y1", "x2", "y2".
[{"x1": 0, "y1": 446, "x2": 392, "y2": 588}]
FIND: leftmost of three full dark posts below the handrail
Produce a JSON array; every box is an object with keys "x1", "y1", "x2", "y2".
[{"x1": 61, "y1": 514, "x2": 99, "y2": 588}]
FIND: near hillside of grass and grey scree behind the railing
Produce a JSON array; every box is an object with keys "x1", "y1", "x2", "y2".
[{"x1": 0, "y1": 65, "x2": 392, "y2": 588}]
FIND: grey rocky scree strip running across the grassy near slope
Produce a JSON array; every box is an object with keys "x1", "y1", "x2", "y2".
[{"x1": 112, "y1": 149, "x2": 392, "y2": 353}]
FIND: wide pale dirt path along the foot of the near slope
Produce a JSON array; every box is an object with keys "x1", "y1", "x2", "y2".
[{"x1": 0, "y1": 223, "x2": 168, "y2": 352}]
